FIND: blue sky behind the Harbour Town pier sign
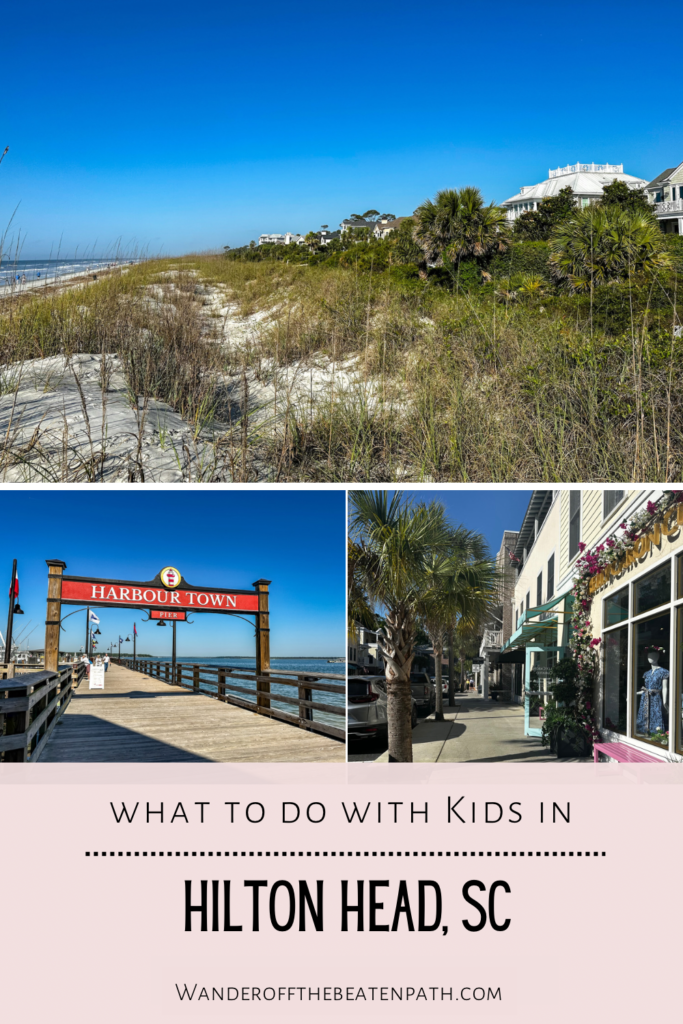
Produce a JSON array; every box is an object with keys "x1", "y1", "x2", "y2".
[{"x1": 0, "y1": 488, "x2": 346, "y2": 657}]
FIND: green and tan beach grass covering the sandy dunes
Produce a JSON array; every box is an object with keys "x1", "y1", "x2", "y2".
[{"x1": 0, "y1": 254, "x2": 683, "y2": 482}]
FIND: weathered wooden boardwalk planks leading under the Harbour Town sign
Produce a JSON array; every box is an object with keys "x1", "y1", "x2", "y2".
[{"x1": 39, "y1": 664, "x2": 346, "y2": 763}]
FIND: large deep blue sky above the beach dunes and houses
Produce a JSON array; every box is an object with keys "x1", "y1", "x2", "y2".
[{"x1": 0, "y1": 0, "x2": 683, "y2": 258}]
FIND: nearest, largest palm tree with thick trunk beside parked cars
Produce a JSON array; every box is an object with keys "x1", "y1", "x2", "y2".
[{"x1": 349, "y1": 490, "x2": 453, "y2": 762}]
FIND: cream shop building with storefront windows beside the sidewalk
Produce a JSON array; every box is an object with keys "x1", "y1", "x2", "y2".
[{"x1": 500, "y1": 488, "x2": 683, "y2": 760}]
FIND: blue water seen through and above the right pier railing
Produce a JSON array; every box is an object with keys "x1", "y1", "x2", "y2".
[{"x1": 133, "y1": 655, "x2": 346, "y2": 729}]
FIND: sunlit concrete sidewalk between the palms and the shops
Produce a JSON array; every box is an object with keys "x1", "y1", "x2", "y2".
[{"x1": 370, "y1": 693, "x2": 593, "y2": 764}]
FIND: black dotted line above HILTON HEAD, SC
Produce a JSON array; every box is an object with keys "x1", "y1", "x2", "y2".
[{"x1": 85, "y1": 850, "x2": 607, "y2": 857}]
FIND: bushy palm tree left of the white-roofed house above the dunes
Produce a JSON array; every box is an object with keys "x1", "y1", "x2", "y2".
[{"x1": 415, "y1": 185, "x2": 508, "y2": 265}]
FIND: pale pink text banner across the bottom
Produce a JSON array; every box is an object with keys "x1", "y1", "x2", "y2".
[{"x1": 0, "y1": 764, "x2": 683, "y2": 1024}]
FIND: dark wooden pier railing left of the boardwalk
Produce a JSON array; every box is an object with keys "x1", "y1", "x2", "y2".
[{"x1": 0, "y1": 665, "x2": 86, "y2": 762}]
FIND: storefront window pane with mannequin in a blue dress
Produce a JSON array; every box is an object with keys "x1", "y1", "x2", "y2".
[{"x1": 633, "y1": 610, "x2": 671, "y2": 748}]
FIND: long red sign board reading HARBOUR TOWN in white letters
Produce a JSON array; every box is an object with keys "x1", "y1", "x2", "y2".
[{"x1": 61, "y1": 579, "x2": 258, "y2": 612}]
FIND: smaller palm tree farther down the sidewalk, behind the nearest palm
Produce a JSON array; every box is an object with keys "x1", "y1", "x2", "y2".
[{"x1": 420, "y1": 544, "x2": 500, "y2": 722}]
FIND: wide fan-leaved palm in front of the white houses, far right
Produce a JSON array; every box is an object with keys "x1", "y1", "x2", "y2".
[{"x1": 550, "y1": 206, "x2": 671, "y2": 292}]
